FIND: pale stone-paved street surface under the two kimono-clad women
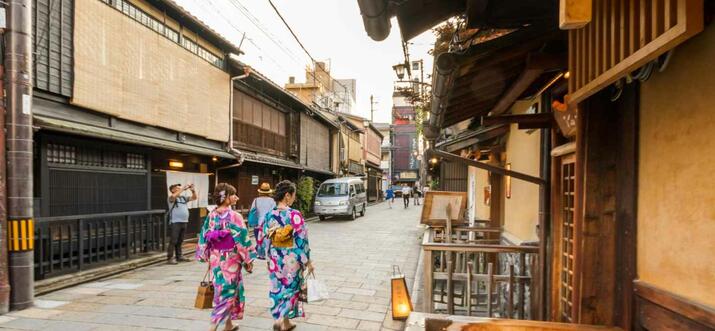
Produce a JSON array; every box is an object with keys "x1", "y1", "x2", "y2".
[{"x1": 0, "y1": 203, "x2": 422, "y2": 331}]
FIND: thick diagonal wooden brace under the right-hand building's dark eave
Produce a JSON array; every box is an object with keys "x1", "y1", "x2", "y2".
[{"x1": 489, "y1": 53, "x2": 566, "y2": 116}]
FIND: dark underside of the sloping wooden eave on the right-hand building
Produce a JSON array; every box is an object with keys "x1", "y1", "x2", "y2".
[{"x1": 433, "y1": 26, "x2": 565, "y2": 128}]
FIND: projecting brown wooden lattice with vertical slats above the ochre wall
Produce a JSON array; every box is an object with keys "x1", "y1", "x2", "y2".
[{"x1": 569, "y1": 0, "x2": 703, "y2": 104}]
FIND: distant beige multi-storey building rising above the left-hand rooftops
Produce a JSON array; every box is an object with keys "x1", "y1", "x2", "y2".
[{"x1": 285, "y1": 62, "x2": 357, "y2": 114}]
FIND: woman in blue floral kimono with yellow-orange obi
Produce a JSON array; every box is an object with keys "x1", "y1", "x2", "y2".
[{"x1": 257, "y1": 180, "x2": 313, "y2": 331}]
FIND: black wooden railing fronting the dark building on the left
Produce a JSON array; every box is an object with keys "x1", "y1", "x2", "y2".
[{"x1": 35, "y1": 209, "x2": 167, "y2": 280}]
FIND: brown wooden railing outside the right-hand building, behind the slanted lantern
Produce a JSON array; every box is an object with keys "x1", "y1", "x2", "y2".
[{"x1": 422, "y1": 227, "x2": 538, "y2": 319}]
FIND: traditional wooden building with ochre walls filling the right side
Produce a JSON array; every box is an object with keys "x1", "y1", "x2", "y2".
[{"x1": 361, "y1": 0, "x2": 715, "y2": 330}]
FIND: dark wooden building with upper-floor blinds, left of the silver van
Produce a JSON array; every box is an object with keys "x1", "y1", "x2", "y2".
[{"x1": 219, "y1": 63, "x2": 339, "y2": 210}]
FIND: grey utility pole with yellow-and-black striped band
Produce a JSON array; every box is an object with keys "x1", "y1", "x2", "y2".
[{"x1": 5, "y1": 0, "x2": 34, "y2": 309}]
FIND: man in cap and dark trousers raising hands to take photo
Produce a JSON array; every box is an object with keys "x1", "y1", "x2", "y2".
[{"x1": 166, "y1": 184, "x2": 198, "y2": 264}]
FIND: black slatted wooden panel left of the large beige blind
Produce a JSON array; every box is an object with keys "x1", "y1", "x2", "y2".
[{"x1": 33, "y1": 0, "x2": 74, "y2": 97}]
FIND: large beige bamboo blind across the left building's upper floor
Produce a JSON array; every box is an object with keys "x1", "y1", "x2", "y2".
[{"x1": 72, "y1": 0, "x2": 230, "y2": 142}]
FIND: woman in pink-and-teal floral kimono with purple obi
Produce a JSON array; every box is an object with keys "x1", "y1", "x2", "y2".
[{"x1": 196, "y1": 183, "x2": 256, "y2": 331}]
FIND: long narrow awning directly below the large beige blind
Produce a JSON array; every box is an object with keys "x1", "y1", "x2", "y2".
[{"x1": 33, "y1": 115, "x2": 236, "y2": 159}]
